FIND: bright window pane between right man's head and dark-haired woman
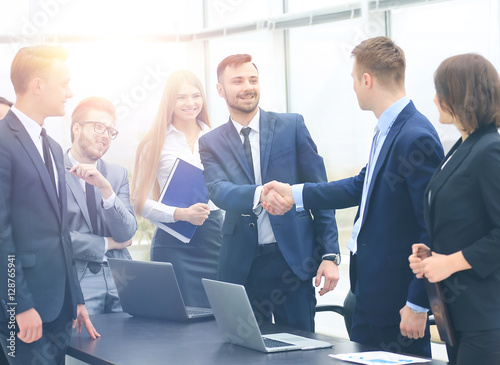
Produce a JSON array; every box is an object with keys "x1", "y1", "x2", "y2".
[{"x1": 391, "y1": 0, "x2": 500, "y2": 150}]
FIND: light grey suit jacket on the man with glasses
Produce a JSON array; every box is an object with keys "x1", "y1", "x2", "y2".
[{"x1": 64, "y1": 154, "x2": 137, "y2": 279}]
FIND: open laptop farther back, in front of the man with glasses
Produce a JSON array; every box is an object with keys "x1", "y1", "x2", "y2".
[{"x1": 108, "y1": 258, "x2": 213, "y2": 321}]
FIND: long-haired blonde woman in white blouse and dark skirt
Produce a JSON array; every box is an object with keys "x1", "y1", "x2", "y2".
[{"x1": 132, "y1": 70, "x2": 222, "y2": 307}]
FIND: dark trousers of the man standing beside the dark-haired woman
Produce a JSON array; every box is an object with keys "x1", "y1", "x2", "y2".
[{"x1": 350, "y1": 288, "x2": 431, "y2": 357}]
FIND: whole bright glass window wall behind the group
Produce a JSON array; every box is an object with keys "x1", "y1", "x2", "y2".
[{"x1": 0, "y1": 0, "x2": 500, "y2": 172}]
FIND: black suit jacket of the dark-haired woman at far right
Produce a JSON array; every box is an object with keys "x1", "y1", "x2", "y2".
[{"x1": 424, "y1": 126, "x2": 500, "y2": 331}]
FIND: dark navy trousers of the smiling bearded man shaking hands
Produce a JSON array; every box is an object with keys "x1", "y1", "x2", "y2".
[{"x1": 245, "y1": 250, "x2": 316, "y2": 332}]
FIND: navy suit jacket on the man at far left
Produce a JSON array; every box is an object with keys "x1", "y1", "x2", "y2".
[{"x1": 0, "y1": 111, "x2": 83, "y2": 322}]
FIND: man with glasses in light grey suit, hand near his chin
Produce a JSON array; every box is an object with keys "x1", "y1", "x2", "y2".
[{"x1": 64, "y1": 97, "x2": 137, "y2": 314}]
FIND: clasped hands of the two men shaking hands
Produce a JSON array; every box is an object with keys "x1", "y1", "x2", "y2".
[{"x1": 260, "y1": 181, "x2": 295, "y2": 215}]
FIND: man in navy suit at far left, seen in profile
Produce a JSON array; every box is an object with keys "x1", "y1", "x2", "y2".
[{"x1": 0, "y1": 46, "x2": 99, "y2": 364}]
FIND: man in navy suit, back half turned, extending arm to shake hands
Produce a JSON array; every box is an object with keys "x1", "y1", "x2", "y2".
[{"x1": 264, "y1": 37, "x2": 443, "y2": 356}]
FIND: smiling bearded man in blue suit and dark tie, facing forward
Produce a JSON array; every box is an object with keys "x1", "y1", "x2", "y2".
[{"x1": 200, "y1": 55, "x2": 340, "y2": 331}]
